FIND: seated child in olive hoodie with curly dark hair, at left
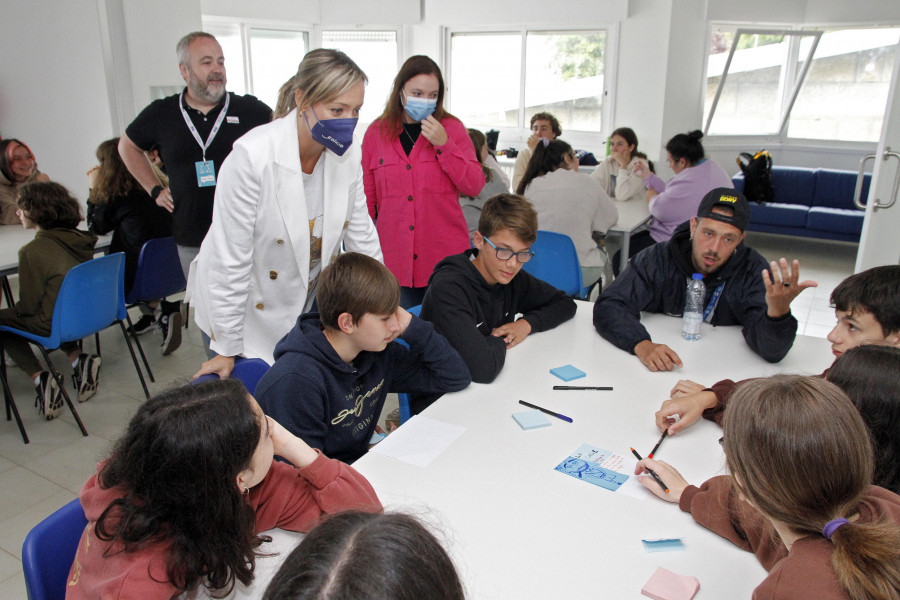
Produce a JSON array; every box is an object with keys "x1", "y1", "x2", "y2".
[{"x1": 0, "y1": 181, "x2": 100, "y2": 420}]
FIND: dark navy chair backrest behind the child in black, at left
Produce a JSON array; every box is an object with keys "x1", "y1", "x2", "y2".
[{"x1": 125, "y1": 237, "x2": 187, "y2": 304}]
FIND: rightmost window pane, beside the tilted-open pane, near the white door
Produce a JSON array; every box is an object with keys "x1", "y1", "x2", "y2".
[{"x1": 788, "y1": 28, "x2": 900, "y2": 142}]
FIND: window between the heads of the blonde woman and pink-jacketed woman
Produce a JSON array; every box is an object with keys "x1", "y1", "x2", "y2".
[{"x1": 322, "y1": 31, "x2": 400, "y2": 126}]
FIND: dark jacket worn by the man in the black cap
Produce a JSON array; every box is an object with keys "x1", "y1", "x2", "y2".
[{"x1": 594, "y1": 222, "x2": 797, "y2": 362}]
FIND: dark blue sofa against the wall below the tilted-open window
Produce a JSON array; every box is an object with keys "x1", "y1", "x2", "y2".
[{"x1": 732, "y1": 167, "x2": 872, "y2": 242}]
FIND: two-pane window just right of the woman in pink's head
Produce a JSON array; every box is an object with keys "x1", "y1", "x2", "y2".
[{"x1": 448, "y1": 31, "x2": 606, "y2": 132}]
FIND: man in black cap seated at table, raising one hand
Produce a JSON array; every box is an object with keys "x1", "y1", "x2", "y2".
[{"x1": 594, "y1": 188, "x2": 816, "y2": 371}]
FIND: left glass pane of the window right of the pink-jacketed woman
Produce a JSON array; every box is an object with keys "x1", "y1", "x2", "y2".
[{"x1": 445, "y1": 33, "x2": 522, "y2": 130}]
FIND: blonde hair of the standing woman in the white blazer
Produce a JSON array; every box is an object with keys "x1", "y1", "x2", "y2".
[{"x1": 272, "y1": 48, "x2": 369, "y2": 119}]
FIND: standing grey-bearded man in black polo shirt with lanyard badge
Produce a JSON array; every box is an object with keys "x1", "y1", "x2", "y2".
[{"x1": 119, "y1": 31, "x2": 272, "y2": 354}]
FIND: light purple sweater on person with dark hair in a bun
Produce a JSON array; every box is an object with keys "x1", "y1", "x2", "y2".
[{"x1": 644, "y1": 159, "x2": 734, "y2": 242}]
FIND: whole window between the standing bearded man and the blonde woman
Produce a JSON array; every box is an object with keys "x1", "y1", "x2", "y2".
[{"x1": 203, "y1": 21, "x2": 309, "y2": 109}]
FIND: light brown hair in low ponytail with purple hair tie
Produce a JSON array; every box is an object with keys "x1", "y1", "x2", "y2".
[{"x1": 725, "y1": 375, "x2": 900, "y2": 600}]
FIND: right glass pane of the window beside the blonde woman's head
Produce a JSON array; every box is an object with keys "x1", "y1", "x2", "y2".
[{"x1": 248, "y1": 28, "x2": 307, "y2": 110}]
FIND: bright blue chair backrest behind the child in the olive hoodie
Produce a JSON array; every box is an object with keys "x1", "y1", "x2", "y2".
[{"x1": 49, "y1": 252, "x2": 125, "y2": 343}]
